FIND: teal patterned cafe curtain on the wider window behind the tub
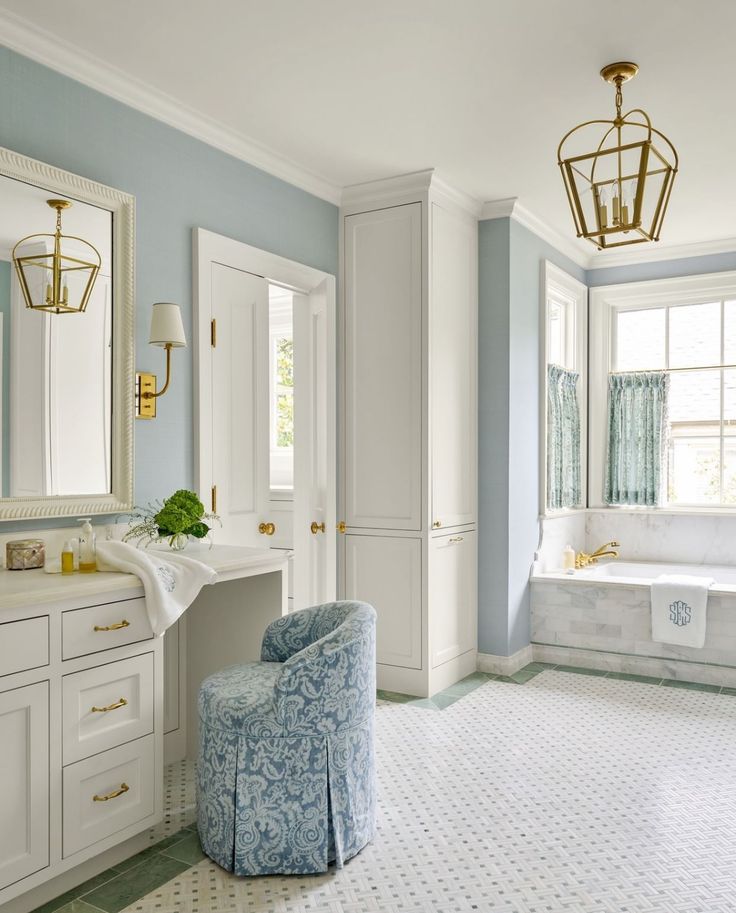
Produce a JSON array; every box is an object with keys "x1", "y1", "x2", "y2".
[{"x1": 605, "y1": 371, "x2": 669, "y2": 507}]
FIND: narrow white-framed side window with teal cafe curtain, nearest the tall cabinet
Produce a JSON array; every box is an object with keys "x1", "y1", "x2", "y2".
[{"x1": 539, "y1": 260, "x2": 588, "y2": 516}]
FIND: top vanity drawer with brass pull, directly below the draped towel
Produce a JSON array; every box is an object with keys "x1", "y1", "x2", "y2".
[{"x1": 61, "y1": 598, "x2": 153, "y2": 659}]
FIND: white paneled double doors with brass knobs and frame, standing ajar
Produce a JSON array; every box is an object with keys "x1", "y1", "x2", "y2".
[{"x1": 195, "y1": 229, "x2": 337, "y2": 608}]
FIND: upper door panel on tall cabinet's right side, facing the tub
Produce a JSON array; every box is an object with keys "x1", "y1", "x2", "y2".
[{"x1": 429, "y1": 204, "x2": 478, "y2": 526}]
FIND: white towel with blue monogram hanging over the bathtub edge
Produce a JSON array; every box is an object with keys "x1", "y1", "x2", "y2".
[{"x1": 652, "y1": 574, "x2": 715, "y2": 647}]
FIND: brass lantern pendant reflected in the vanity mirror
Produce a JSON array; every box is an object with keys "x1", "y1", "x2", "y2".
[{"x1": 13, "y1": 200, "x2": 102, "y2": 314}]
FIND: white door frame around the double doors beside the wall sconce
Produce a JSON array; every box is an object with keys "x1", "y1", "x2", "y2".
[{"x1": 192, "y1": 228, "x2": 337, "y2": 583}]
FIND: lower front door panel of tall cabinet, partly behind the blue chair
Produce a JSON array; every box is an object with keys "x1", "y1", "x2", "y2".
[{"x1": 345, "y1": 535, "x2": 422, "y2": 669}]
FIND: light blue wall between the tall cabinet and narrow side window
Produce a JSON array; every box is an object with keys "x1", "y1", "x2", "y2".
[{"x1": 478, "y1": 219, "x2": 585, "y2": 656}]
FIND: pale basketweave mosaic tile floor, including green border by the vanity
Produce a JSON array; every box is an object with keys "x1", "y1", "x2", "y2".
[{"x1": 41, "y1": 667, "x2": 736, "y2": 913}]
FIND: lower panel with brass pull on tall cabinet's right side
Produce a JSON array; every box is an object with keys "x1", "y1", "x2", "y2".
[{"x1": 429, "y1": 532, "x2": 477, "y2": 669}]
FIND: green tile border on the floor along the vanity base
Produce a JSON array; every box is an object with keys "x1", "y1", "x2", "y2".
[{"x1": 33, "y1": 825, "x2": 198, "y2": 913}]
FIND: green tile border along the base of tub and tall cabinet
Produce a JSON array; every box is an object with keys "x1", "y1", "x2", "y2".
[{"x1": 376, "y1": 663, "x2": 736, "y2": 710}]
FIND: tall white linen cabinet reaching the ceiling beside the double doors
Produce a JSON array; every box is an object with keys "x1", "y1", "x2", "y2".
[{"x1": 339, "y1": 172, "x2": 478, "y2": 696}]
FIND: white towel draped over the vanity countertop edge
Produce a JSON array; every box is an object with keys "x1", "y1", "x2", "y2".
[{"x1": 97, "y1": 540, "x2": 217, "y2": 637}]
